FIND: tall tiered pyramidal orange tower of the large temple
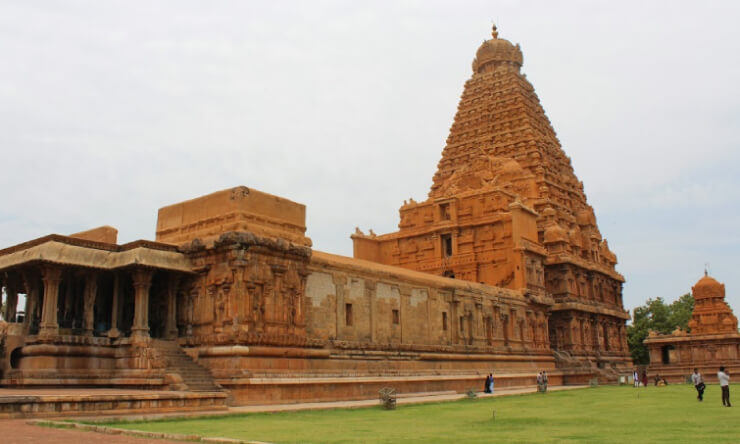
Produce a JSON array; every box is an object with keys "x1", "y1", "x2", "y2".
[{"x1": 352, "y1": 26, "x2": 630, "y2": 367}]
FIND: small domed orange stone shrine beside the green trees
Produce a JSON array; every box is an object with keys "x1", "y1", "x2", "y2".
[{"x1": 644, "y1": 272, "x2": 740, "y2": 382}]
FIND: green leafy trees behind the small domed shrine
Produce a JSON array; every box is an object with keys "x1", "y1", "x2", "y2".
[{"x1": 627, "y1": 293, "x2": 694, "y2": 364}]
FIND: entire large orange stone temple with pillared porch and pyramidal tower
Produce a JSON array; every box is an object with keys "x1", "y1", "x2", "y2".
[{"x1": 0, "y1": 28, "x2": 631, "y2": 410}]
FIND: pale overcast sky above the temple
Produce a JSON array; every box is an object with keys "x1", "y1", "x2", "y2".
[{"x1": 0, "y1": 0, "x2": 740, "y2": 314}]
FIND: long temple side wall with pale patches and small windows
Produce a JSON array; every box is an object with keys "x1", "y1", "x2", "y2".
[{"x1": 306, "y1": 252, "x2": 549, "y2": 351}]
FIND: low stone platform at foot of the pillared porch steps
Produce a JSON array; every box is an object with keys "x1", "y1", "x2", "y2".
[{"x1": 0, "y1": 388, "x2": 227, "y2": 418}]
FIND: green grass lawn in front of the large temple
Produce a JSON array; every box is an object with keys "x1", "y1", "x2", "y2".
[{"x1": 95, "y1": 385, "x2": 740, "y2": 444}]
